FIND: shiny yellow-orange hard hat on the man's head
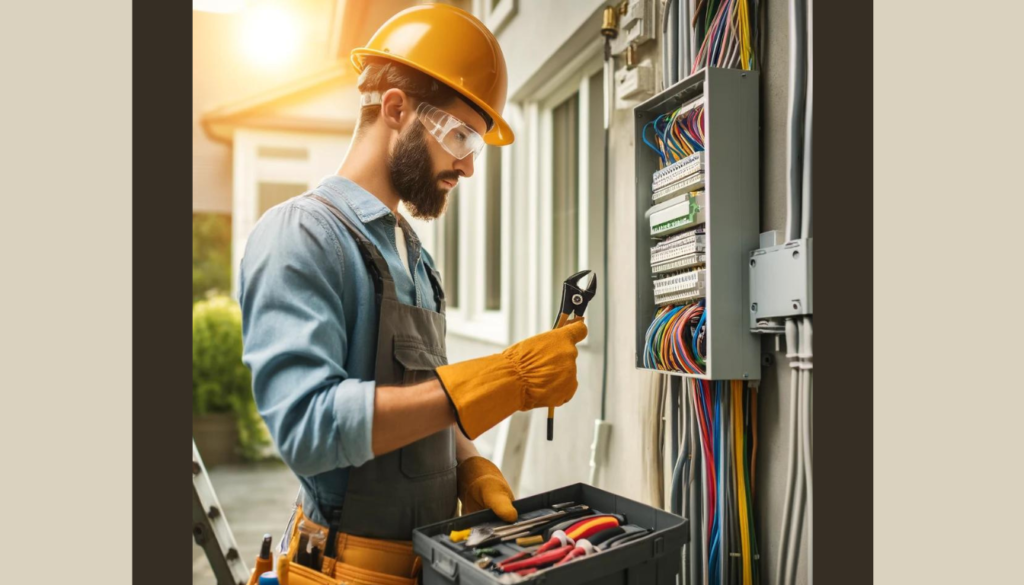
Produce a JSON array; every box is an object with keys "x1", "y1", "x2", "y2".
[{"x1": 351, "y1": 4, "x2": 515, "y2": 147}]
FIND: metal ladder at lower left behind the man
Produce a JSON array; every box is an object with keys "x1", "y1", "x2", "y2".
[{"x1": 193, "y1": 438, "x2": 250, "y2": 585}]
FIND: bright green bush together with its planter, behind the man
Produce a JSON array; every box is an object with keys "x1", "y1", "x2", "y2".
[{"x1": 193, "y1": 296, "x2": 269, "y2": 466}]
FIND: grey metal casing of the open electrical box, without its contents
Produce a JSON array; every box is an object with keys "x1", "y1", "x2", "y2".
[{"x1": 634, "y1": 68, "x2": 761, "y2": 380}]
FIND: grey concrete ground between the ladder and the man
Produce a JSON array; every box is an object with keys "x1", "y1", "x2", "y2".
[{"x1": 193, "y1": 462, "x2": 299, "y2": 585}]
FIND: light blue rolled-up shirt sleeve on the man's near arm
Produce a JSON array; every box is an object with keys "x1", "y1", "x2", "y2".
[{"x1": 239, "y1": 203, "x2": 375, "y2": 476}]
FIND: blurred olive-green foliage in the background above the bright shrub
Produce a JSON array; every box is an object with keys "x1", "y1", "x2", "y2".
[{"x1": 193, "y1": 213, "x2": 231, "y2": 303}]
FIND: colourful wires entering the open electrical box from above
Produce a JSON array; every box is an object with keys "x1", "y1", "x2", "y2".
[{"x1": 691, "y1": 0, "x2": 760, "y2": 73}]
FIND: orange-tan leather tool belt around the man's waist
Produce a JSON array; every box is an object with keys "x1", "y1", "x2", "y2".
[{"x1": 248, "y1": 506, "x2": 421, "y2": 585}]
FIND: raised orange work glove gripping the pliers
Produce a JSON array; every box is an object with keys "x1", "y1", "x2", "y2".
[{"x1": 437, "y1": 318, "x2": 587, "y2": 440}]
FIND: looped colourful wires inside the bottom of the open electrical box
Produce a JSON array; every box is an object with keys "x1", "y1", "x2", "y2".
[{"x1": 643, "y1": 299, "x2": 708, "y2": 374}]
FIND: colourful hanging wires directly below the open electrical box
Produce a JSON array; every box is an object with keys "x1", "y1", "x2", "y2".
[{"x1": 687, "y1": 379, "x2": 761, "y2": 585}]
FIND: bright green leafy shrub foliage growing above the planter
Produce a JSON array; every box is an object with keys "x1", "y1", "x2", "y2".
[{"x1": 193, "y1": 296, "x2": 270, "y2": 459}]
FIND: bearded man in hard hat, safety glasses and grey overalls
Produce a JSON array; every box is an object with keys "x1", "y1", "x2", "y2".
[{"x1": 240, "y1": 5, "x2": 587, "y2": 583}]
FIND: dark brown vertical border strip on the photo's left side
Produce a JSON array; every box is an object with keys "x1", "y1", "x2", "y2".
[{"x1": 134, "y1": 2, "x2": 191, "y2": 585}]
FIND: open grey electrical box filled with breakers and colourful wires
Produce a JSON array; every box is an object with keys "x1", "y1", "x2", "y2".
[{"x1": 634, "y1": 68, "x2": 761, "y2": 380}]
